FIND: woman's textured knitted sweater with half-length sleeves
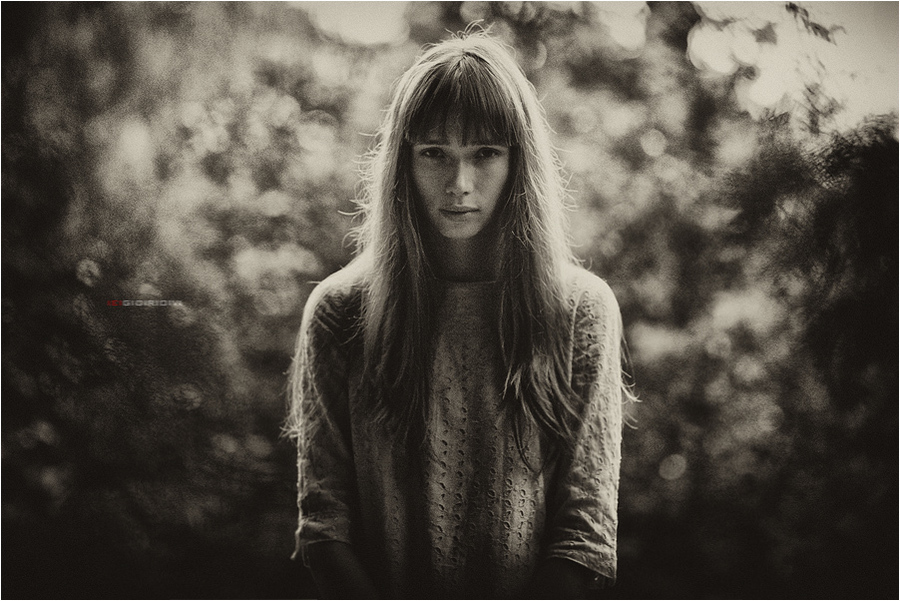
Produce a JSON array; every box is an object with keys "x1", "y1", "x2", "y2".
[{"x1": 297, "y1": 267, "x2": 622, "y2": 598}]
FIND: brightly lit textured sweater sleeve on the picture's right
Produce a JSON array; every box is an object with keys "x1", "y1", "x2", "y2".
[{"x1": 546, "y1": 276, "x2": 622, "y2": 581}]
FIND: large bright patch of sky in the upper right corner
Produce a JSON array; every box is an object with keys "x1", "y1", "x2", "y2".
[{"x1": 688, "y1": 2, "x2": 898, "y2": 131}]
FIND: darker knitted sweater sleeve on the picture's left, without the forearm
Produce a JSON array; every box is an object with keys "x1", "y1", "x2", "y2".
[{"x1": 294, "y1": 284, "x2": 356, "y2": 555}]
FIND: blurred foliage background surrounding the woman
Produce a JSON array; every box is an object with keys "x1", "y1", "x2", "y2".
[{"x1": 2, "y1": 2, "x2": 898, "y2": 598}]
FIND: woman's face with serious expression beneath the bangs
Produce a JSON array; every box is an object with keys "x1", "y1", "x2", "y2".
[{"x1": 412, "y1": 127, "x2": 510, "y2": 240}]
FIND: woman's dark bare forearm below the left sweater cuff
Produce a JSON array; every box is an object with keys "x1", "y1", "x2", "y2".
[{"x1": 305, "y1": 541, "x2": 379, "y2": 599}]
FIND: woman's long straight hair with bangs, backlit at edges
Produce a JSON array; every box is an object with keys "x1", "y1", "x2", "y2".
[{"x1": 342, "y1": 33, "x2": 579, "y2": 450}]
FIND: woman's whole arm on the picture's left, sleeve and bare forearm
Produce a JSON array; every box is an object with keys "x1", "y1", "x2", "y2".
[{"x1": 291, "y1": 283, "x2": 377, "y2": 599}]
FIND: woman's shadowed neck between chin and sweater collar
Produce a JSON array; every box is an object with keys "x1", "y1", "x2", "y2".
[{"x1": 428, "y1": 235, "x2": 497, "y2": 282}]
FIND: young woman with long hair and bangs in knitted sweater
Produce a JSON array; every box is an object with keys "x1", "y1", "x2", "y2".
[{"x1": 290, "y1": 34, "x2": 623, "y2": 598}]
